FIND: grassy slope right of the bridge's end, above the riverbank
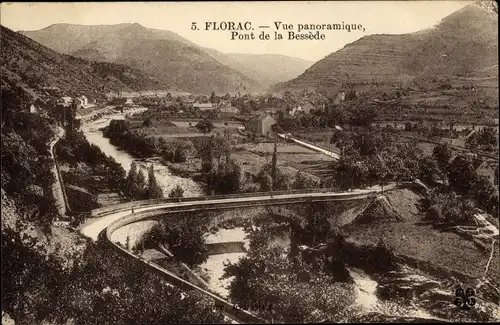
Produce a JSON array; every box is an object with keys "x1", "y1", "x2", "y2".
[{"x1": 346, "y1": 190, "x2": 500, "y2": 279}]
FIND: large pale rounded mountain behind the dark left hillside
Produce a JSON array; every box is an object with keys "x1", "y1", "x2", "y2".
[{"x1": 20, "y1": 24, "x2": 261, "y2": 94}]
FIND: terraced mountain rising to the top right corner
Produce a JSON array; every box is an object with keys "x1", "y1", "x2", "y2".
[{"x1": 274, "y1": 5, "x2": 498, "y2": 91}]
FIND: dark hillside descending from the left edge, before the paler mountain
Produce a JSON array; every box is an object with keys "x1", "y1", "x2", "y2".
[{"x1": 0, "y1": 26, "x2": 166, "y2": 97}]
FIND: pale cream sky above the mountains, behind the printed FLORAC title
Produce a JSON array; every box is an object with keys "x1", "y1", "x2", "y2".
[{"x1": 0, "y1": 1, "x2": 472, "y2": 61}]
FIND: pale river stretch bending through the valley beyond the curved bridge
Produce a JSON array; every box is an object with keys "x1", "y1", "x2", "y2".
[{"x1": 82, "y1": 107, "x2": 203, "y2": 197}]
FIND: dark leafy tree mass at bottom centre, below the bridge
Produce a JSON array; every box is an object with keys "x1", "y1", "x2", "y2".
[{"x1": 224, "y1": 247, "x2": 355, "y2": 323}]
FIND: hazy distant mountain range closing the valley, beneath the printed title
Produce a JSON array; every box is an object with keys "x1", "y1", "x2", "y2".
[{"x1": 20, "y1": 24, "x2": 312, "y2": 93}]
